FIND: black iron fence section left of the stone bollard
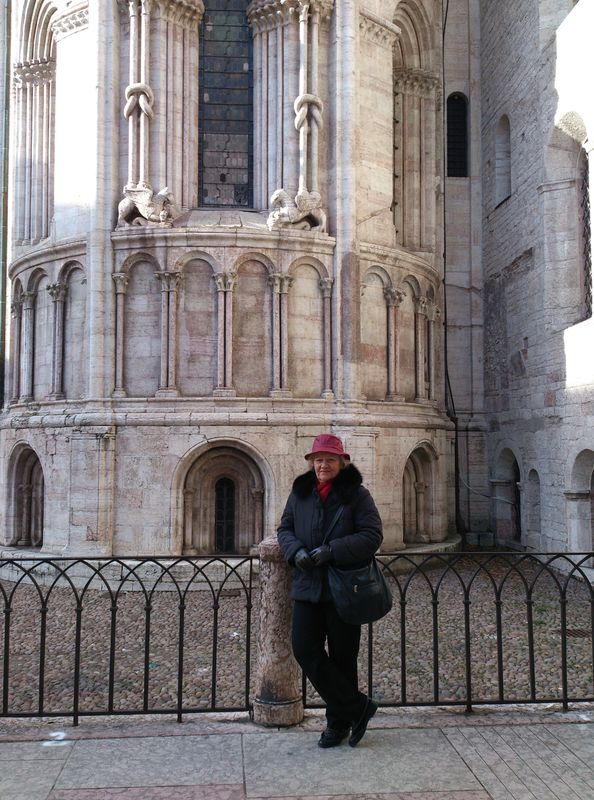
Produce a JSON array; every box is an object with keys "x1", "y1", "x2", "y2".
[{"x1": 0, "y1": 557, "x2": 258, "y2": 725}]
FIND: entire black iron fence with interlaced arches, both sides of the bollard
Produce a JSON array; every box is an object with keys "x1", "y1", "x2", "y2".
[{"x1": 0, "y1": 552, "x2": 594, "y2": 724}]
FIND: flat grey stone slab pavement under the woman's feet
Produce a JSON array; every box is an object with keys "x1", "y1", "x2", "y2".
[{"x1": 0, "y1": 705, "x2": 594, "y2": 800}]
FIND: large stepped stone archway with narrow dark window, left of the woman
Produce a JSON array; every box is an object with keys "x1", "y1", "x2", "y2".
[{"x1": 183, "y1": 446, "x2": 264, "y2": 555}]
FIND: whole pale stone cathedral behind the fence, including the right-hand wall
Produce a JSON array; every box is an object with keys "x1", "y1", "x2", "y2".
[{"x1": 0, "y1": 0, "x2": 594, "y2": 556}]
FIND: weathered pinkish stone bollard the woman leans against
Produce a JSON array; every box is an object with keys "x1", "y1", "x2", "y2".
[{"x1": 254, "y1": 536, "x2": 303, "y2": 727}]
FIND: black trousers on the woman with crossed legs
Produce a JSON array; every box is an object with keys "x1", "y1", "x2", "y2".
[{"x1": 293, "y1": 600, "x2": 367, "y2": 730}]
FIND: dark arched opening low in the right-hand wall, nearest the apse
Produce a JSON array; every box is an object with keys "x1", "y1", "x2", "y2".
[{"x1": 491, "y1": 448, "x2": 522, "y2": 543}]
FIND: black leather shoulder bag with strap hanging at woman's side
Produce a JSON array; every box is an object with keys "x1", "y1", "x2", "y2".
[{"x1": 324, "y1": 506, "x2": 392, "y2": 625}]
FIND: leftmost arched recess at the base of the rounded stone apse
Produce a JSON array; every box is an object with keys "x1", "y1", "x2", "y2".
[{"x1": 12, "y1": 447, "x2": 45, "y2": 547}]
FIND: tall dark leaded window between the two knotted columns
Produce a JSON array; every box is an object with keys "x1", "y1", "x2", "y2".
[{"x1": 199, "y1": 0, "x2": 253, "y2": 207}]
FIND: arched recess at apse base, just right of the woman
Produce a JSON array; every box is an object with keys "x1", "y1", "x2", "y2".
[{"x1": 402, "y1": 447, "x2": 435, "y2": 544}]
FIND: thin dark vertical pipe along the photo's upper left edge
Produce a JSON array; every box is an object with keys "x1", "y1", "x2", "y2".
[{"x1": 0, "y1": 0, "x2": 11, "y2": 408}]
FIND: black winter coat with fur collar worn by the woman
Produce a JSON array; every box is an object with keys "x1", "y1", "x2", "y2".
[{"x1": 278, "y1": 464, "x2": 383, "y2": 603}]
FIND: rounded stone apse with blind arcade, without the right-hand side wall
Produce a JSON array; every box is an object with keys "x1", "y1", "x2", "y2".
[{"x1": 0, "y1": 0, "x2": 452, "y2": 555}]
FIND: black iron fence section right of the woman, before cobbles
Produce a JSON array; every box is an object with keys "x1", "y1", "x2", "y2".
[{"x1": 303, "y1": 552, "x2": 594, "y2": 711}]
